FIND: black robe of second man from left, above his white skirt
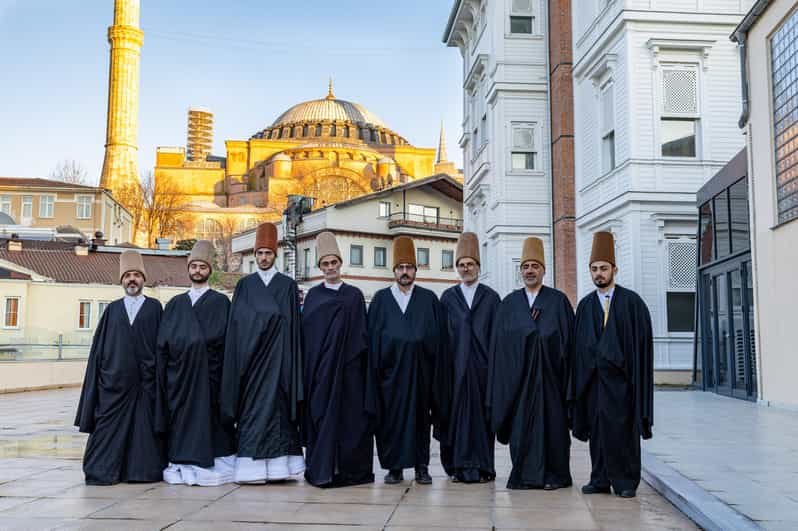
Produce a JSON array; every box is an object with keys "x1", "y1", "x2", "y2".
[{"x1": 157, "y1": 289, "x2": 235, "y2": 468}]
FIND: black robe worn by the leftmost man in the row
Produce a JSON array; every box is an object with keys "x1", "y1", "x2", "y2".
[{"x1": 75, "y1": 297, "x2": 166, "y2": 485}]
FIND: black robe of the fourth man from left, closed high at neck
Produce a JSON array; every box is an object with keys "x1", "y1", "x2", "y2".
[{"x1": 302, "y1": 284, "x2": 374, "y2": 487}]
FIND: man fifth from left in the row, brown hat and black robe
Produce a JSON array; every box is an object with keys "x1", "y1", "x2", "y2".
[{"x1": 366, "y1": 236, "x2": 444, "y2": 485}]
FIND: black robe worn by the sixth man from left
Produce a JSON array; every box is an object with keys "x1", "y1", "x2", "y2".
[{"x1": 435, "y1": 284, "x2": 501, "y2": 482}]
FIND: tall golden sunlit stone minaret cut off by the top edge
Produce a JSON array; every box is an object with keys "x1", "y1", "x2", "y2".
[{"x1": 100, "y1": 0, "x2": 144, "y2": 193}]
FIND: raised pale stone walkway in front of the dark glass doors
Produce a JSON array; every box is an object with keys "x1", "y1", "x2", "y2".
[{"x1": 643, "y1": 391, "x2": 798, "y2": 530}]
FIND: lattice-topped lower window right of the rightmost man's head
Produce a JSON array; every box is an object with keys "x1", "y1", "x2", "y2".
[{"x1": 665, "y1": 238, "x2": 697, "y2": 332}]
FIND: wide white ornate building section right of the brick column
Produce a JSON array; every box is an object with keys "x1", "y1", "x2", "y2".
[{"x1": 572, "y1": 0, "x2": 752, "y2": 381}]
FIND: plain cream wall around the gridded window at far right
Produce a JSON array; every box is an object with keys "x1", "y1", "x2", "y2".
[{"x1": 747, "y1": 0, "x2": 798, "y2": 407}]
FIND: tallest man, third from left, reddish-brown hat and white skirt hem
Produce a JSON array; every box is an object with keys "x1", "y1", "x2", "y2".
[{"x1": 221, "y1": 223, "x2": 305, "y2": 483}]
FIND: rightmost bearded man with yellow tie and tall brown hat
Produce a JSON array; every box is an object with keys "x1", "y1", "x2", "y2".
[{"x1": 570, "y1": 232, "x2": 654, "y2": 498}]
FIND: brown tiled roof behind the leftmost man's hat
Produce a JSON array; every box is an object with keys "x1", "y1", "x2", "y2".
[{"x1": 0, "y1": 240, "x2": 191, "y2": 287}]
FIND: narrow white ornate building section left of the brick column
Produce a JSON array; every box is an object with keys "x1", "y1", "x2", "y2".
[{"x1": 443, "y1": 0, "x2": 554, "y2": 295}]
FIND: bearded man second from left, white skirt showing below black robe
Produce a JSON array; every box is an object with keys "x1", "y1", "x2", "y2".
[{"x1": 156, "y1": 240, "x2": 235, "y2": 486}]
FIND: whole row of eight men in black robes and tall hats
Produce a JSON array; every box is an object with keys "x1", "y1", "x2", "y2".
[{"x1": 76, "y1": 223, "x2": 653, "y2": 497}]
